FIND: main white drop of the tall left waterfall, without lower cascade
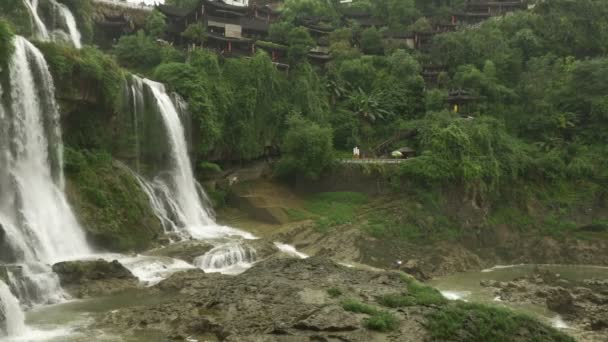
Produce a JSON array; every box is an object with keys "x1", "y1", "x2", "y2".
[{"x1": 0, "y1": 37, "x2": 90, "y2": 263}]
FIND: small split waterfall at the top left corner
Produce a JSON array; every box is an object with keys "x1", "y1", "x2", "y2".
[{"x1": 23, "y1": 0, "x2": 82, "y2": 49}]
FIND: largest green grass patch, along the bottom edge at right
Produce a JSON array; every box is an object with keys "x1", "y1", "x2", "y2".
[{"x1": 426, "y1": 302, "x2": 574, "y2": 342}]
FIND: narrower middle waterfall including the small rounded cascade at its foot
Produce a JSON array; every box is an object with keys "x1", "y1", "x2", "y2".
[{"x1": 125, "y1": 76, "x2": 255, "y2": 274}]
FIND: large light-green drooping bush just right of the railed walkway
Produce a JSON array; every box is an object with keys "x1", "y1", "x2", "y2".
[{"x1": 402, "y1": 112, "x2": 530, "y2": 201}]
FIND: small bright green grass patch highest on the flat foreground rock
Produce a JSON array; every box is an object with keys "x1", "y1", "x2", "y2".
[{"x1": 378, "y1": 280, "x2": 447, "y2": 308}]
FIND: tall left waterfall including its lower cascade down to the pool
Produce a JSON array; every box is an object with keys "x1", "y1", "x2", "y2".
[{"x1": 0, "y1": 36, "x2": 91, "y2": 336}]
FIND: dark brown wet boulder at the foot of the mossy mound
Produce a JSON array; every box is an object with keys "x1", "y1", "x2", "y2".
[{"x1": 53, "y1": 259, "x2": 139, "y2": 298}]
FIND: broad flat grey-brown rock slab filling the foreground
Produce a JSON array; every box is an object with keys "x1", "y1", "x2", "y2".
[{"x1": 100, "y1": 257, "x2": 424, "y2": 342}]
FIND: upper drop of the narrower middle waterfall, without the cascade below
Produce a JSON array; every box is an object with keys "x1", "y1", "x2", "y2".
[{"x1": 128, "y1": 76, "x2": 254, "y2": 239}]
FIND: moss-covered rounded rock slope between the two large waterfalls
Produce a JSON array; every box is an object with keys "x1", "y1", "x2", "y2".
[{"x1": 65, "y1": 148, "x2": 163, "y2": 252}]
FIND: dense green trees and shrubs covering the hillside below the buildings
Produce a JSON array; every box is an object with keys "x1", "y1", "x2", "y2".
[{"x1": 105, "y1": 0, "x2": 608, "y2": 200}]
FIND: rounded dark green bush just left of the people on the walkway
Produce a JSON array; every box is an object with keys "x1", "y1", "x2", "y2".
[{"x1": 276, "y1": 115, "x2": 333, "y2": 179}]
